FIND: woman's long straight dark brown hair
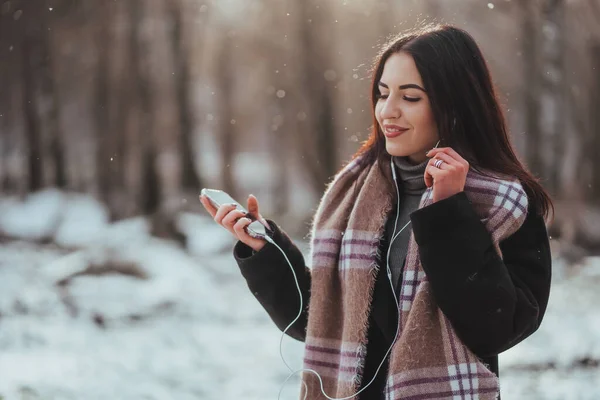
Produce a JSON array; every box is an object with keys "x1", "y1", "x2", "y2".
[{"x1": 353, "y1": 25, "x2": 554, "y2": 222}]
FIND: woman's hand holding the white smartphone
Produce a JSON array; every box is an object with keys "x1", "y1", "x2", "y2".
[{"x1": 200, "y1": 195, "x2": 271, "y2": 251}]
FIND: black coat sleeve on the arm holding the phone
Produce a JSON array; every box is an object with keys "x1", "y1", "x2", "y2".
[{"x1": 233, "y1": 220, "x2": 311, "y2": 342}]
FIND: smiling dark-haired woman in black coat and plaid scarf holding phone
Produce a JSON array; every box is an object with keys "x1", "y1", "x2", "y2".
[{"x1": 201, "y1": 25, "x2": 552, "y2": 400}]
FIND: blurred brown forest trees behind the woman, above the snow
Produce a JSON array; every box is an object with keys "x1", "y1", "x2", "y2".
[{"x1": 0, "y1": 0, "x2": 600, "y2": 250}]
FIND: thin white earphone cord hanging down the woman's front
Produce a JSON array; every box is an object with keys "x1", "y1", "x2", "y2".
[{"x1": 265, "y1": 140, "x2": 440, "y2": 400}]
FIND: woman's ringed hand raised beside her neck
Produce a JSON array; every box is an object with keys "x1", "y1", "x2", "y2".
[{"x1": 425, "y1": 147, "x2": 469, "y2": 203}]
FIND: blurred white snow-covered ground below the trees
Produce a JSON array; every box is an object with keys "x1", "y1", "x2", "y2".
[{"x1": 0, "y1": 191, "x2": 600, "y2": 400}]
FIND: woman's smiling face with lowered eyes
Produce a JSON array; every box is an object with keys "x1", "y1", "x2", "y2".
[{"x1": 375, "y1": 52, "x2": 438, "y2": 164}]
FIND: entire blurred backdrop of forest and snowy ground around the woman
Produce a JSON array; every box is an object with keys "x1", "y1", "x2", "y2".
[{"x1": 0, "y1": 0, "x2": 600, "y2": 400}]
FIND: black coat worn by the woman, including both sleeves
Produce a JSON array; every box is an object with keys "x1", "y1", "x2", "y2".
[{"x1": 234, "y1": 192, "x2": 551, "y2": 400}]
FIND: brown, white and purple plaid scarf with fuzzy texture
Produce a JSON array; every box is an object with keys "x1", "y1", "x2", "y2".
[{"x1": 300, "y1": 157, "x2": 527, "y2": 400}]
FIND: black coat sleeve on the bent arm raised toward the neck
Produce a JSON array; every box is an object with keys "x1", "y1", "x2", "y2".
[{"x1": 411, "y1": 192, "x2": 552, "y2": 357}]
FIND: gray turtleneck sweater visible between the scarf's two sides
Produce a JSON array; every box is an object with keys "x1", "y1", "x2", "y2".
[{"x1": 382, "y1": 157, "x2": 429, "y2": 297}]
